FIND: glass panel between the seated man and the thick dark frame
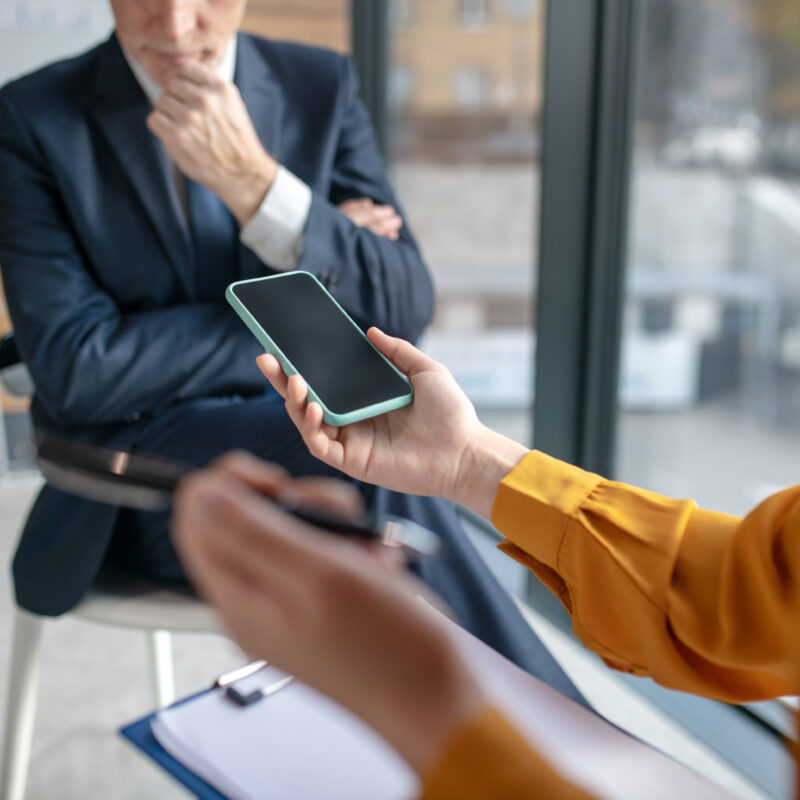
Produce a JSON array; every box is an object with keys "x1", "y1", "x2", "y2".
[{"x1": 389, "y1": 0, "x2": 544, "y2": 441}]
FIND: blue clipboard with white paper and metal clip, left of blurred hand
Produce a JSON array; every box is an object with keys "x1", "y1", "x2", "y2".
[{"x1": 121, "y1": 662, "x2": 419, "y2": 800}]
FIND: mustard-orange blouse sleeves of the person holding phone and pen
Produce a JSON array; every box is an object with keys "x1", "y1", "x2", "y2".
[{"x1": 423, "y1": 451, "x2": 800, "y2": 800}]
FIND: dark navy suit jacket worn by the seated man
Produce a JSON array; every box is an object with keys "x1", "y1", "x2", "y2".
[{"x1": 0, "y1": 34, "x2": 433, "y2": 615}]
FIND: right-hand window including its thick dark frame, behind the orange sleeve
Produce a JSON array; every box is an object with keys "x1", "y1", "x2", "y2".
[{"x1": 531, "y1": 0, "x2": 800, "y2": 797}]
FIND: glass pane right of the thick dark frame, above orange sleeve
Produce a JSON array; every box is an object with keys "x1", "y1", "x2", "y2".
[{"x1": 617, "y1": 0, "x2": 800, "y2": 514}]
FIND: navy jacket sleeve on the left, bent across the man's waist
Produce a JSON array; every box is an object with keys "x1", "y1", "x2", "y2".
[{"x1": 0, "y1": 93, "x2": 264, "y2": 425}]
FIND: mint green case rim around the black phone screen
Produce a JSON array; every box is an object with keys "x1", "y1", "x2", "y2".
[{"x1": 225, "y1": 270, "x2": 414, "y2": 427}]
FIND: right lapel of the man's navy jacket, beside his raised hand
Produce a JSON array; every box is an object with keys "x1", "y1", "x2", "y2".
[{"x1": 234, "y1": 33, "x2": 283, "y2": 279}]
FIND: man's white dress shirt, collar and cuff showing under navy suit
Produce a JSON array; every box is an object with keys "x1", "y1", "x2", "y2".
[{"x1": 122, "y1": 36, "x2": 311, "y2": 270}]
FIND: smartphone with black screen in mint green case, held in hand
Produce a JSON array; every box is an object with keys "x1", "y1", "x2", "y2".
[{"x1": 225, "y1": 271, "x2": 413, "y2": 426}]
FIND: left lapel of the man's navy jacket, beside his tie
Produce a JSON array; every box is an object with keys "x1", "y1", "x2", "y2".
[{"x1": 90, "y1": 36, "x2": 194, "y2": 297}]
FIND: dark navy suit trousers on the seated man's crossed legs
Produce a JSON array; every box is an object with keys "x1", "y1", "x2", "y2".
[{"x1": 110, "y1": 391, "x2": 584, "y2": 703}]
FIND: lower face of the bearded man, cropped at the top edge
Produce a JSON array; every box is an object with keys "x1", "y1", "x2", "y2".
[{"x1": 111, "y1": 0, "x2": 246, "y2": 86}]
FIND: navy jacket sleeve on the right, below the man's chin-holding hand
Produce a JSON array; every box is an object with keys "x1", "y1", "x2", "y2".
[{"x1": 299, "y1": 58, "x2": 434, "y2": 341}]
